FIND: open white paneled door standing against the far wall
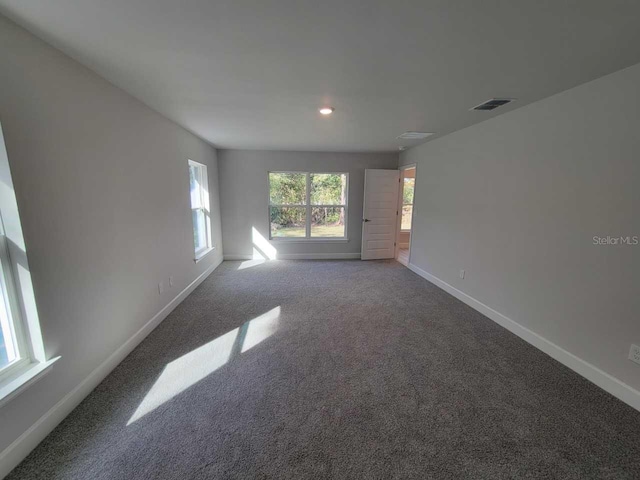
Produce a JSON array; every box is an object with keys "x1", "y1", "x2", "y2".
[{"x1": 361, "y1": 169, "x2": 400, "y2": 260}]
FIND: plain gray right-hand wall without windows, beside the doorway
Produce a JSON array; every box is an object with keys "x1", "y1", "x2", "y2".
[{"x1": 401, "y1": 65, "x2": 640, "y2": 405}]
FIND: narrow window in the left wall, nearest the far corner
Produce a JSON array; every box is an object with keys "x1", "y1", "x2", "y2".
[{"x1": 189, "y1": 160, "x2": 213, "y2": 260}]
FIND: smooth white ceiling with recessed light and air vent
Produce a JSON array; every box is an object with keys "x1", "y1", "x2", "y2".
[{"x1": 0, "y1": 0, "x2": 640, "y2": 151}]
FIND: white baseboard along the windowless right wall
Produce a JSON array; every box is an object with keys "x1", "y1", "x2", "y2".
[{"x1": 409, "y1": 264, "x2": 640, "y2": 410}]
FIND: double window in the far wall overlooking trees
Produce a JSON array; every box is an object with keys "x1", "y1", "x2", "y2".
[{"x1": 269, "y1": 172, "x2": 349, "y2": 239}]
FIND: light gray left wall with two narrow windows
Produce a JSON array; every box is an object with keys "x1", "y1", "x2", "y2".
[{"x1": 0, "y1": 17, "x2": 222, "y2": 477}]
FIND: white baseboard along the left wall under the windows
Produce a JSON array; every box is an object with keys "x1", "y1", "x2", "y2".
[{"x1": 0, "y1": 258, "x2": 222, "y2": 479}]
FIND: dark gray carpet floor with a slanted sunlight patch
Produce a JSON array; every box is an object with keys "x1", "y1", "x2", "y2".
[{"x1": 8, "y1": 261, "x2": 640, "y2": 480}]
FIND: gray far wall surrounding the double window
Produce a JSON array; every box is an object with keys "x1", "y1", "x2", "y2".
[{"x1": 218, "y1": 150, "x2": 398, "y2": 258}]
